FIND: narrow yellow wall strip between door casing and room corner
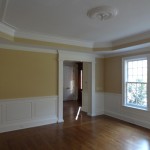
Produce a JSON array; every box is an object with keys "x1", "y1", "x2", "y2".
[{"x1": 95, "y1": 58, "x2": 104, "y2": 92}]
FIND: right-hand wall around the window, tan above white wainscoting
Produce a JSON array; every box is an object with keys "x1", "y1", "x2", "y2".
[{"x1": 104, "y1": 48, "x2": 150, "y2": 128}]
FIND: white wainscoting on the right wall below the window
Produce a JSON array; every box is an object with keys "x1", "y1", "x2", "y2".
[{"x1": 104, "y1": 93, "x2": 150, "y2": 129}]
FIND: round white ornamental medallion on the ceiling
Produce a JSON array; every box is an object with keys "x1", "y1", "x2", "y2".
[{"x1": 87, "y1": 6, "x2": 118, "y2": 20}]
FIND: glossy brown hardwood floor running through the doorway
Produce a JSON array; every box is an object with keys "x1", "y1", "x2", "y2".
[{"x1": 0, "y1": 99, "x2": 150, "y2": 150}]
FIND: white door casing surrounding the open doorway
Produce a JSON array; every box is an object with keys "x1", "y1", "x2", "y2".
[{"x1": 58, "y1": 50, "x2": 95, "y2": 122}]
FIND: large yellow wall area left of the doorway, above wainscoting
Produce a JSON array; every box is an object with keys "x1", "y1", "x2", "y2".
[{"x1": 0, "y1": 49, "x2": 58, "y2": 99}]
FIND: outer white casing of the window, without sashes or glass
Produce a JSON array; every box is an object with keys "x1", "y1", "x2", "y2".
[{"x1": 122, "y1": 54, "x2": 150, "y2": 111}]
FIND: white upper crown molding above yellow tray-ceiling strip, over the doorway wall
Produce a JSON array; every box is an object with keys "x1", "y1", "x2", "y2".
[{"x1": 0, "y1": 21, "x2": 93, "y2": 48}]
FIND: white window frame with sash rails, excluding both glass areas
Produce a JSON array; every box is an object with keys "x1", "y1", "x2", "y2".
[{"x1": 122, "y1": 54, "x2": 150, "y2": 111}]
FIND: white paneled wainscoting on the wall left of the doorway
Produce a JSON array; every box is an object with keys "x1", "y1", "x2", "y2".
[{"x1": 0, "y1": 96, "x2": 58, "y2": 132}]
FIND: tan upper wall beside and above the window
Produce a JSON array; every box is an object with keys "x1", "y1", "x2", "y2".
[{"x1": 104, "y1": 51, "x2": 150, "y2": 94}]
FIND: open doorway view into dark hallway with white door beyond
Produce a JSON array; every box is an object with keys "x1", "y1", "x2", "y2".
[{"x1": 63, "y1": 61, "x2": 83, "y2": 122}]
